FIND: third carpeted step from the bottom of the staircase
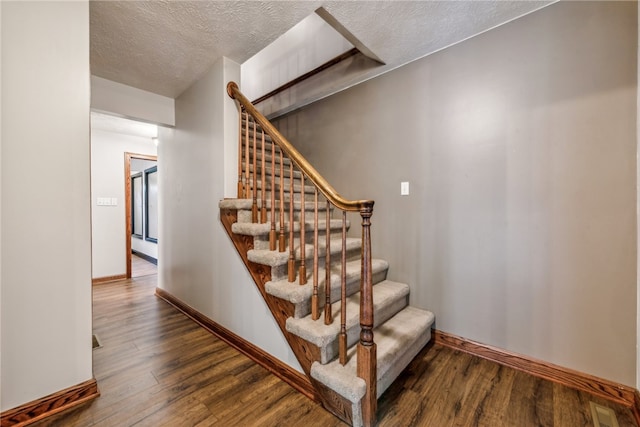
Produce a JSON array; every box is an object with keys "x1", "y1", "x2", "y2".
[{"x1": 265, "y1": 259, "x2": 389, "y2": 318}]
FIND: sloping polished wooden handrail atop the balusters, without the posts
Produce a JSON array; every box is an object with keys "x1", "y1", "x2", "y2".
[{"x1": 227, "y1": 82, "x2": 374, "y2": 212}]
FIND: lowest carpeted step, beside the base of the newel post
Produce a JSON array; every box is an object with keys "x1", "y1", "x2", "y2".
[{"x1": 311, "y1": 306, "x2": 434, "y2": 403}]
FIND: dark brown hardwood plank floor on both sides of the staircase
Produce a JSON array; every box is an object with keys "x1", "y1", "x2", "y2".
[{"x1": 33, "y1": 275, "x2": 637, "y2": 427}]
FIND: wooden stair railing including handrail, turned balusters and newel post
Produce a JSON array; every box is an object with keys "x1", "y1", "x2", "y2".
[{"x1": 227, "y1": 82, "x2": 377, "y2": 426}]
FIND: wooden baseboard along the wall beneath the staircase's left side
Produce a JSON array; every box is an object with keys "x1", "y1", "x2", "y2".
[{"x1": 156, "y1": 288, "x2": 320, "y2": 403}]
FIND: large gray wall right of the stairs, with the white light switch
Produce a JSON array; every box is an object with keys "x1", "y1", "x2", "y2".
[{"x1": 278, "y1": 2, "x2": 638, "y2": 385}]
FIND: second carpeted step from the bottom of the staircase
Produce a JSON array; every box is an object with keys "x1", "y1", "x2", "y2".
[{"x1": 286, "y1": 280, "x2": 409, "y2": 364}]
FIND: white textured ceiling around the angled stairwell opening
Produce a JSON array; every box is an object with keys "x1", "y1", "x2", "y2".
[{"x1": 90, "y1": 0, "x2": 553, "y2": 98}]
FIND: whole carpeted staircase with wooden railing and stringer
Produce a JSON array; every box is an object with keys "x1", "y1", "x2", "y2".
[{"x1": 220, "y1": 82, "x2": 434, "y2": 426}]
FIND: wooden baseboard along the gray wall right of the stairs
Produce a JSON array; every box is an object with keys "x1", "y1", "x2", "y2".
[{"x1": 433, "y1": 329, "x2": 640, "y2": 410}]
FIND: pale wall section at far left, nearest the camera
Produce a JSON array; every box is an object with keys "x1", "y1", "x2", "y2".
[{"x1": 0, "y1": 1, "x2": 93, "y2": 411}]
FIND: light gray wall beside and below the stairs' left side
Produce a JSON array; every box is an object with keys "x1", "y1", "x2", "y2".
[{"x1": 158, "y1": 58, "x2": 300, "y2": 369}]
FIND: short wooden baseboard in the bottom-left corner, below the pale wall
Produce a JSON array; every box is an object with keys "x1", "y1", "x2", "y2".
[{"x1": 0, "y1": 379, "x2": 100, "y2": 427}]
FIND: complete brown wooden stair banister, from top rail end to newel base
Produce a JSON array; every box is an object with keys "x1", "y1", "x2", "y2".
[{"x1": 227, "y1": 82, "x2": 377, "y2": 420}]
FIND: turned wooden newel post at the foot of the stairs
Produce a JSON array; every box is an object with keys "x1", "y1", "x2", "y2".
[{"x1": 357, "y1": 203, "x2": 377, "y2": 426}]
